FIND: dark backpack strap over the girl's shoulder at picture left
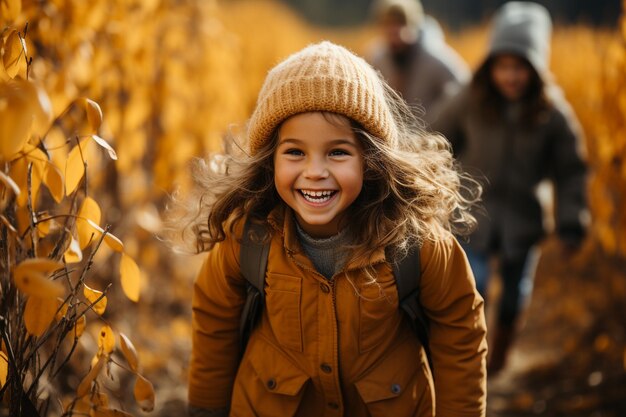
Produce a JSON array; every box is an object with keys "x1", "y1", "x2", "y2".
[{"x1": 239, "y1": 219, "x2": 270, "y2": 355}]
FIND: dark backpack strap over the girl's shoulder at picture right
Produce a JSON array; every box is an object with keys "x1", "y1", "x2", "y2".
[{"x1": 388, "y1": 245, "x2": 434, "y2": 373}]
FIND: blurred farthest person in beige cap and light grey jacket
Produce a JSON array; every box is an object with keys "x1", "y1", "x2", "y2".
[{"x1": 368, "y1": 0, "x2": 470, "y2": 122}]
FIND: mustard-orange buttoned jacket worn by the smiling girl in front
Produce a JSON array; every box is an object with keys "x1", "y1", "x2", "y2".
[{"x1": 189, "y1": 209, "x2": 487, "y2": 417}]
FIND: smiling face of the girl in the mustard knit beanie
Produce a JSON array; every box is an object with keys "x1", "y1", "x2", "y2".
[{"x1": 274, "y1": 112, "x2": 364, "y2": 237}]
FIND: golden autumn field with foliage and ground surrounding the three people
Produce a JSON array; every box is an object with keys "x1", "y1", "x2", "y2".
[{"x1": 0, "y1": 0, "x2": 626, "y2": 417}]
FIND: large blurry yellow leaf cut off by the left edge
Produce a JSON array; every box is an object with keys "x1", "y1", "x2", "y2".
[{"x1": 0, "y1": 79, "x2": 39, "y2": 159}]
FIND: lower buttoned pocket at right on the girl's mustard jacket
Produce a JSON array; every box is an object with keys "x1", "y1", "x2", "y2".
[{"x1": 355, "y1": 338, "x2": 435, "y2": 417}]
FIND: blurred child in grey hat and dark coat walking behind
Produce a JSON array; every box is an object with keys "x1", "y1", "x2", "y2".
[{"x1": 432, "y1": 2, "x2": 586, "y2": 374}]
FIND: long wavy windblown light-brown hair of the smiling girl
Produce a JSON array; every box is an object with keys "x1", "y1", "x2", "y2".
[{"x1": 166, "y1": 81, "x2": 481, "y2": 277}]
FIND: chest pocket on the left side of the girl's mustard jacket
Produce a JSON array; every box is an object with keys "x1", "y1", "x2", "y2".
[{"x1": 265, "y1": 273, "x2": 302, "y2": 352}]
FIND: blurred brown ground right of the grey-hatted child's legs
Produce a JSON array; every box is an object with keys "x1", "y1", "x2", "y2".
[{"x1": 487, "y1": 240, "x2": 626, "y2": 417}]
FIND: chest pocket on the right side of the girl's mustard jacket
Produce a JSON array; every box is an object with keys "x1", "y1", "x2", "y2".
[{"x1": 358, "y1": 279, "x2": 400, "y2": 353}]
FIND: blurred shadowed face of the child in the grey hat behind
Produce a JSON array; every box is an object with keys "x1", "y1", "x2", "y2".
[{"x1": 491, "y1": 54, "x2": 532, "y2": 101}]
